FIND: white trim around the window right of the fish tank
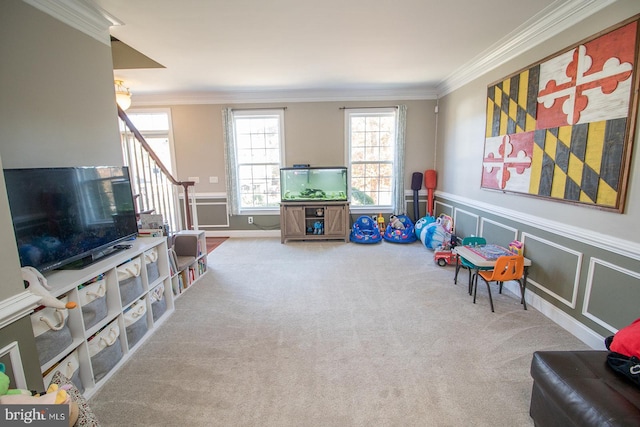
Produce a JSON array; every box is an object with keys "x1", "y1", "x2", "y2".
[{"x1": 344, "y1": 107, "x2": 398, "y2": 213}]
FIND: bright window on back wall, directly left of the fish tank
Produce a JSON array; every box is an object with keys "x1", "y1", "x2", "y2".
[{"x1": 233, "y1": 110, "x2": 284, "y2": 211}]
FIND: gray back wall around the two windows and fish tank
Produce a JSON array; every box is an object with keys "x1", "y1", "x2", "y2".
[{"x1": 162, "y1": 100, "x2": 436, "y2": 231}]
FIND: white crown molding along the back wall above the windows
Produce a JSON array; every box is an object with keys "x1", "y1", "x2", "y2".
[{"x1": 132, "y1": 89, "x2": 437, "y2": 108}]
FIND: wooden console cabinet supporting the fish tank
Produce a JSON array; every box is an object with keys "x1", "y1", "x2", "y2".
[{"x1": 280, "y1": 202, "x2": 351, "y2": 243}]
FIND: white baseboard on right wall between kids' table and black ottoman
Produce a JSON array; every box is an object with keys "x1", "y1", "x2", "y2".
[{"x1": 503, "y1": 282, "x2": 606, "y2": 350}]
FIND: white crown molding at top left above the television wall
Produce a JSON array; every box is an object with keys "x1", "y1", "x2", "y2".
[{"x1": 22, "y1": 0, "x2": 117, "y2": 46}]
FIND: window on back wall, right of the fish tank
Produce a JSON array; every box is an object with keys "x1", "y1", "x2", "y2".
[{"x1": 345, "y1": 108, "x2": 397, "y2": 210}]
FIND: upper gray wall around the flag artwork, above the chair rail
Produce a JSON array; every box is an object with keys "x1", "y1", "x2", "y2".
[{"x1": 437, "y1": 0, "x2": 640, "y2": 242}]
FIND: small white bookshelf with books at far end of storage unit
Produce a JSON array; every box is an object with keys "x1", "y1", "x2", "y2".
[{"x1": 171, "y1": 230, "x2": 208, "y2": 298}]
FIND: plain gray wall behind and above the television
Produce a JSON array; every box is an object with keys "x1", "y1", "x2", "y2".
[{"x1": 0, "y1": 0, "x2": 122, "y2": 300}]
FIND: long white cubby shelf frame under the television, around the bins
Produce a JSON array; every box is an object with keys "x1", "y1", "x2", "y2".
[{"x1": 33, "y1": 237, "x2": 174, "y2": 398}]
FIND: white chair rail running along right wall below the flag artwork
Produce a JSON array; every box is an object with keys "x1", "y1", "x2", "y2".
[{"x1": 436, "y1": 191, "x2": 640, "y2": 261}]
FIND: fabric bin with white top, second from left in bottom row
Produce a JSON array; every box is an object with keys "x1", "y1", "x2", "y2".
[{"x1": 87, "y1": 320, "x2": 122, "y2": 382}]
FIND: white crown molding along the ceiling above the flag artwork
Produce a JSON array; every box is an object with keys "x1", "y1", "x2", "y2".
[{"x1": 437, "y1": 0, "x2": 617, "y2": 97}]
